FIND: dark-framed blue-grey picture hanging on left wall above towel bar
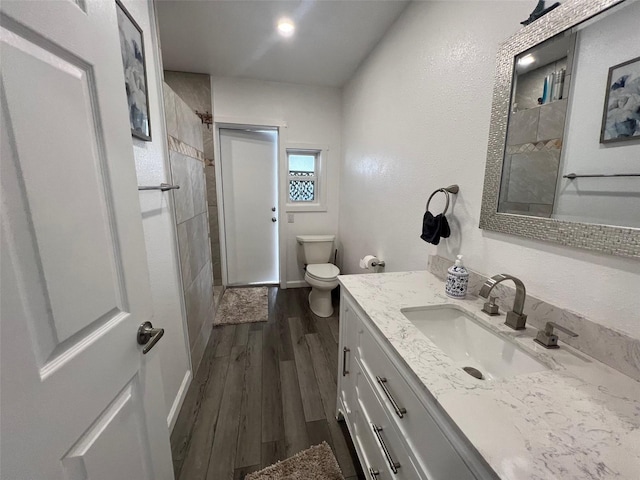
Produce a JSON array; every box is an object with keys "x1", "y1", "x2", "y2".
[{"x1": 116, "y1": 0, "x2": 151, "y2": 142}]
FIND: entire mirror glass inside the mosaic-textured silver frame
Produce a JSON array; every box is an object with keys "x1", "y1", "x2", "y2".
[{"x1": 498, "y1": 2, "x2": 640, "y2": 228}]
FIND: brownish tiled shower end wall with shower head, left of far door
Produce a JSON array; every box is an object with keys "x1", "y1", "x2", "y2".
[{"x1": 164, "y1": 70, "x2": 222, "y2": 285}]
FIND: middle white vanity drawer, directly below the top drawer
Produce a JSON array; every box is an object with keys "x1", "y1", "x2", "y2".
[{"x1": 355, "y1": 360, "x2": 426, "y2": 480}]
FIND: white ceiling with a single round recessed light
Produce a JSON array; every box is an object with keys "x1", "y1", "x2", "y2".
[{"x1": 156, "y1": 0, "x2": 408, "y2": 87}]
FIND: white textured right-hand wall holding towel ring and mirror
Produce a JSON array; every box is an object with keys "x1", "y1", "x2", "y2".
[{"x1": 340, "y1": 1, "x2": 640, "y2": 338}]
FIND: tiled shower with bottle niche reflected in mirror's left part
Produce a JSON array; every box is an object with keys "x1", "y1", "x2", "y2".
[{"x1": 498, "y1": 34, "x2": 576, "y2": 217}]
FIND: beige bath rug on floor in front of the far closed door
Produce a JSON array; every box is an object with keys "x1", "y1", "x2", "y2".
[{"x1": 213, "y1": 287, "x2": 269, "y2": 325}]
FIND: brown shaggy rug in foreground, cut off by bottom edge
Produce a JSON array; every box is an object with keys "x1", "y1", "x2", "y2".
[{"x1": 245, "y1": 442, "x2": 344, "y2": 480}]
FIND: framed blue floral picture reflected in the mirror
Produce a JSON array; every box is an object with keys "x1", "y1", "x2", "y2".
[{"x1": 600, "y1": 57, "x2": 640, "y2": 143}]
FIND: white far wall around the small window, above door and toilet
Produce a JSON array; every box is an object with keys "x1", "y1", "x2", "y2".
[{"x1": 211, "y1": 78, "x2": 342, "y2": 286}]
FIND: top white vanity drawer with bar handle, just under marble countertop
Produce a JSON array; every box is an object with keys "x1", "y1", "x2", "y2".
[{"x1": 358, "y1": 326, "x2": 475, "y2": 480}]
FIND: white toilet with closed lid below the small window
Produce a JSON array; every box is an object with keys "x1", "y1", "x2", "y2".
[{"x1": 296, "y1": 235, "x2": 340, "y2": 317}]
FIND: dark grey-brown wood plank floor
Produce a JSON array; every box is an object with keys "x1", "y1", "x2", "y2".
[{"x1": 171, "y1": 287, "x2": 364, "y2": 480}]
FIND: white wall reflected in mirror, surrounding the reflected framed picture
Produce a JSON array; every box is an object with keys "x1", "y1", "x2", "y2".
[{"x1": 554, "y1": 2, "x2": 640, "y2": 228}]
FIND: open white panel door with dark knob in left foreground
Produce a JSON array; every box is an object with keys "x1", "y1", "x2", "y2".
[{"x1": 0, "y1": 0, "x2": 173, "y2": 480}]
